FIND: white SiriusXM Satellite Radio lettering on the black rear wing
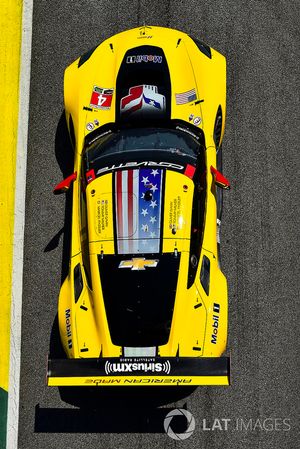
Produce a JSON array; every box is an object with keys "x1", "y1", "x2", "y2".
[{"x1": 105, "y1": 358, "x2": 171, "y2": 375}]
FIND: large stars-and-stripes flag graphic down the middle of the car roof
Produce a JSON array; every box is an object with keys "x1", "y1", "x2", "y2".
[{"x1": 115, "y1": 168, "x2": 163, "y2": 254}]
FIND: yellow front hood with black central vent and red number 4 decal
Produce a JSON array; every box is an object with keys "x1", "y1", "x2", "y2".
[{"x1": 70, "y1": 27, "x2": 202, "y2": 135}]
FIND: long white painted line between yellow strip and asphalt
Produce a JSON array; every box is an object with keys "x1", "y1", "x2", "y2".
[{"x1": 6, "y1": 0, "x2": 33, "y2": 449}]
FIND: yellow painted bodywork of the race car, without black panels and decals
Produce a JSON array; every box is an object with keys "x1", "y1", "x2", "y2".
[{"x1": 55, "y1": 27, "x2": 228, "y2": 385}]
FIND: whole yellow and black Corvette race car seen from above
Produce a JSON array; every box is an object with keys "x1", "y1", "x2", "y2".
[{"x1": 48, "y1": 26, "x2": 230, "y2": 386}]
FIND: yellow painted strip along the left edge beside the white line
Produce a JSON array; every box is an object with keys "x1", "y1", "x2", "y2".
[{"x1": 0, "y1": 0, "x2": 22, "y2": 391}]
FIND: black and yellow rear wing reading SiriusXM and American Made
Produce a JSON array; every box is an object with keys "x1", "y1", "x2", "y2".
[{"x1": 47, "y1": 357, "x2": 230, "y2": 387}]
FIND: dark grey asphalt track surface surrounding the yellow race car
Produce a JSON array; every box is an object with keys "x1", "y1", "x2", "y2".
[{"x1": 19, "y1": 0, "x2": 300, "y2": 449}]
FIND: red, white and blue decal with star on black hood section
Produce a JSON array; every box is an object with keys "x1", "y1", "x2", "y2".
[{"x1": 120, "y1": 84, "x2": 166, "y2": 114}]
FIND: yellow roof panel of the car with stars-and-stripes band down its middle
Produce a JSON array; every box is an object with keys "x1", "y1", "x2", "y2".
[{"x1": 86, "y1": 167, "x2": 194, "y2": 256}]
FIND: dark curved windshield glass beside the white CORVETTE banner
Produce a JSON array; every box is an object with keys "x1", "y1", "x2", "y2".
[{"x1": 85, "y1": 128, "x2": 201, "y2": 168}]
